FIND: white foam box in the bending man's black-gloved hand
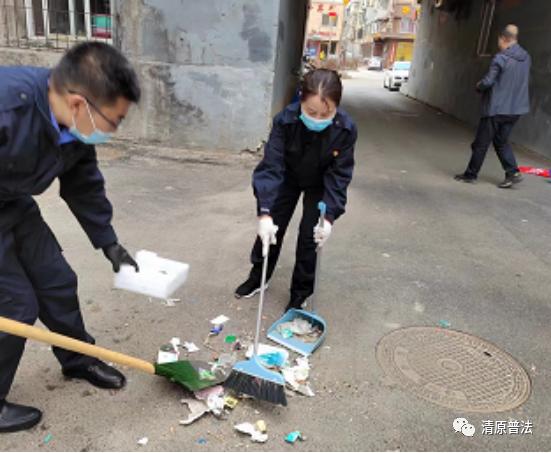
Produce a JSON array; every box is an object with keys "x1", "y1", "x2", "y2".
[{"x1": 114, "y1": 250, "x2": 189, "y2": 299}]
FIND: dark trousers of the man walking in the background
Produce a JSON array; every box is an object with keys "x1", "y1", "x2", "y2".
[{"x1": 465, "y1": 115, "x2": 519, "y2": 178}]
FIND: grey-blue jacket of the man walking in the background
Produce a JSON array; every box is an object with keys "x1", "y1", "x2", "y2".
[{"x1": 478, "y1": 44, "x2": 532, "y2": 117}]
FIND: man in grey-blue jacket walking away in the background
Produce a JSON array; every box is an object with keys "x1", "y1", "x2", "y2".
[{"x1": 455, "y1": 25, "x2": 531, "y2": 189}]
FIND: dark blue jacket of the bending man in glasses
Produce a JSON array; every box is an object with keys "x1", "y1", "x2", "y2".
[{"x1": 0, "y1": 66, "x2": 117, "y2": 248}]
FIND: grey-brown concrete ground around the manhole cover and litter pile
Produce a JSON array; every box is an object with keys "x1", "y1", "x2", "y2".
[{"x1": 4, "y1": 69, "x2": 551, "y2": 451}]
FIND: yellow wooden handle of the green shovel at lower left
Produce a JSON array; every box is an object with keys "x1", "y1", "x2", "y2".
[{"x1": 0, "y1": 316, "x2": 155, "y2": 374}]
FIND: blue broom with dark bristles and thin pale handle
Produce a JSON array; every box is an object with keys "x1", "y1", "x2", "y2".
[{"x1": 223, "y1": 238, "x2": 287, "y2": 406}]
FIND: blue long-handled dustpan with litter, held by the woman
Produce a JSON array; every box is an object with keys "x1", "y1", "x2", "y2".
[{"x1": 268, "y1": 201, "x2": 327, "y2": 357}]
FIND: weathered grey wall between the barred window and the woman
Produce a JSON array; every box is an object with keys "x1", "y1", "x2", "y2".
[{"x1": 115, "y1": 0, "x2": 294, "y2": 150}]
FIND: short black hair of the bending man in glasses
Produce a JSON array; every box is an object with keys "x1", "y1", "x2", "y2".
[{"x1": 51, "y1": 42, "x2": 141, "y2": 105}]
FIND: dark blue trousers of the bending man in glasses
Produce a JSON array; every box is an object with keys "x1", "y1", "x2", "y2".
[{"x1": 0, "y1": 213, "x2": 94, "y2": 400}]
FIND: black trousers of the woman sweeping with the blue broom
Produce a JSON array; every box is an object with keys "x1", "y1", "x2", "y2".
[{"x1": 250, "y1": 183, "x2": 324, "y2": 301}]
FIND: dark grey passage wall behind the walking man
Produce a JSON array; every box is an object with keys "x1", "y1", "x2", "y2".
[{"x1": 403, "y1": 0, "x2": 551, "y2": 156}]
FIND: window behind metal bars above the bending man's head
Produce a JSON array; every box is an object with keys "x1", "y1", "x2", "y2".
[{"x1": 25, "y1": 0, "x2": 113, "y2": 43}]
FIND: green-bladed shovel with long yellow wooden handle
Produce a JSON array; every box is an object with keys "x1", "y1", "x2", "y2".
[{"x1": 0, "y1": 316, "x2": 226, "y2": 392}]
